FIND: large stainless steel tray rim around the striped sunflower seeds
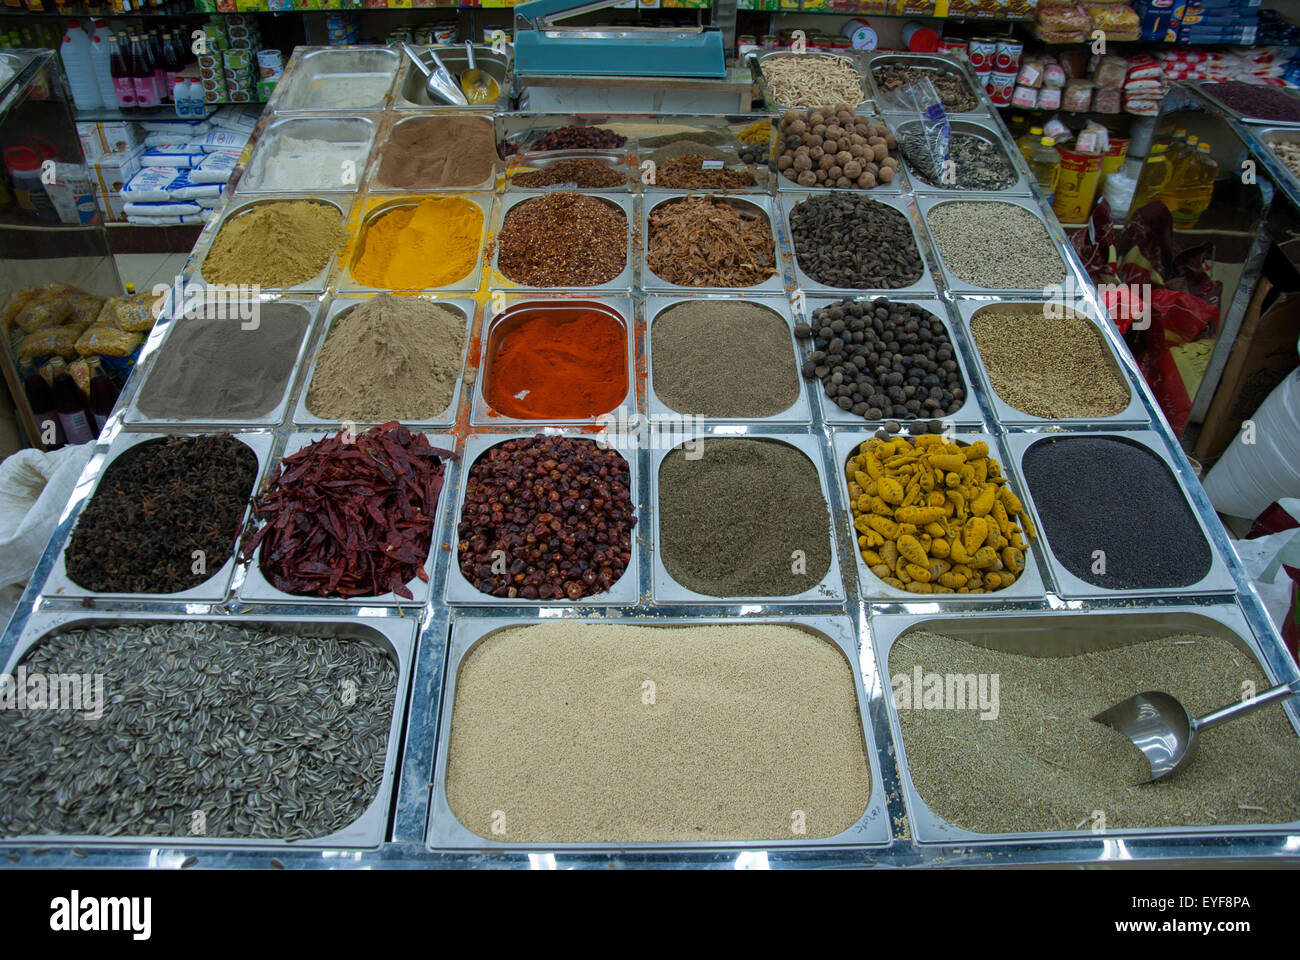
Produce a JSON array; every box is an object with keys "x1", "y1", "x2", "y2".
[{"x1": 0, "y1": 610, "x2": 416, "y2": 856}]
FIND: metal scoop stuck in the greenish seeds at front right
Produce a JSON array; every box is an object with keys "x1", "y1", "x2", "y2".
[{"x1": 1092, "y1": 680, "x2": 1300, "y2": 786}]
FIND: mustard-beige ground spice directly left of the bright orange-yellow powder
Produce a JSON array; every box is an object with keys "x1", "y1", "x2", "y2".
[{"x1": 202, "y1": 200, "x2": 347, "y2": 289}]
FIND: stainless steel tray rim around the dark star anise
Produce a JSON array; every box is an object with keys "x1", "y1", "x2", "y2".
[{"x1": 42, "y1": 431, "x2": 276, "y2": 604}]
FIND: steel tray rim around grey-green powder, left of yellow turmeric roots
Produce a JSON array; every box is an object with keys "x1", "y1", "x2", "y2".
[{"x1": 650, "y1": 433, "x2": 845, "y2": 604}]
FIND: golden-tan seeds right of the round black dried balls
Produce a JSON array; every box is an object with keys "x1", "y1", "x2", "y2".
[{"x1": 971, "y1": 307, "x2": 1128, "y2": 419}]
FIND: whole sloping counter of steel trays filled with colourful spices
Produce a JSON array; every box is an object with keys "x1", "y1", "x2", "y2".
[{"x1": 0, "y1": 42, "x2": 1300, "y2": 866}]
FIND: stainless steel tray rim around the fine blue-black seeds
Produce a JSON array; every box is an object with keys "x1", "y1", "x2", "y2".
[{"x1": 1004, "y1": 431, "x2": 1236, "y2": 598}]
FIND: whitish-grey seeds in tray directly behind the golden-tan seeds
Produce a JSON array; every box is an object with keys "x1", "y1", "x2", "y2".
[{"x1": 927, "y1": 200, "x2": 1066, "y2": 290}]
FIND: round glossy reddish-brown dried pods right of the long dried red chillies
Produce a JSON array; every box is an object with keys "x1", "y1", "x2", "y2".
[{"x1": 458, "y1": 434, "x2": 637, "y2": 600}]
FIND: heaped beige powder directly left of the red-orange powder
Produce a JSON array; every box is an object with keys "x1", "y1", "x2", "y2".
[{"x1": 307, "y1": 294, "x2": 467, "y2": 423}]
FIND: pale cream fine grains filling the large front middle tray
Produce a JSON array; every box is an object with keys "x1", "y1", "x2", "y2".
[{"x1": 447, "y1": 620, "x2": 871, "y2": 843}]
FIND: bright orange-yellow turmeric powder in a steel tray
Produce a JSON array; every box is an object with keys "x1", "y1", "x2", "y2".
[{"x1": 352, "y1": 196, "x2": 484, "y2": 290}]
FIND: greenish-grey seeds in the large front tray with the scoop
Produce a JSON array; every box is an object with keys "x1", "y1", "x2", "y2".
[{"x1": 889, "y1": 628, "x2": 1300, "y2": 834}]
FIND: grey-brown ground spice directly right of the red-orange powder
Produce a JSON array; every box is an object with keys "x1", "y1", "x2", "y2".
[{"x1": 650, "y1": 300, "x2": 800, "y2": 418}]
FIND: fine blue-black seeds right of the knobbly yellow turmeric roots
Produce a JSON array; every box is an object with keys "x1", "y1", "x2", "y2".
[{"x1": 1022, "y1": 437, "x2": 1212, "y2": 591}]
